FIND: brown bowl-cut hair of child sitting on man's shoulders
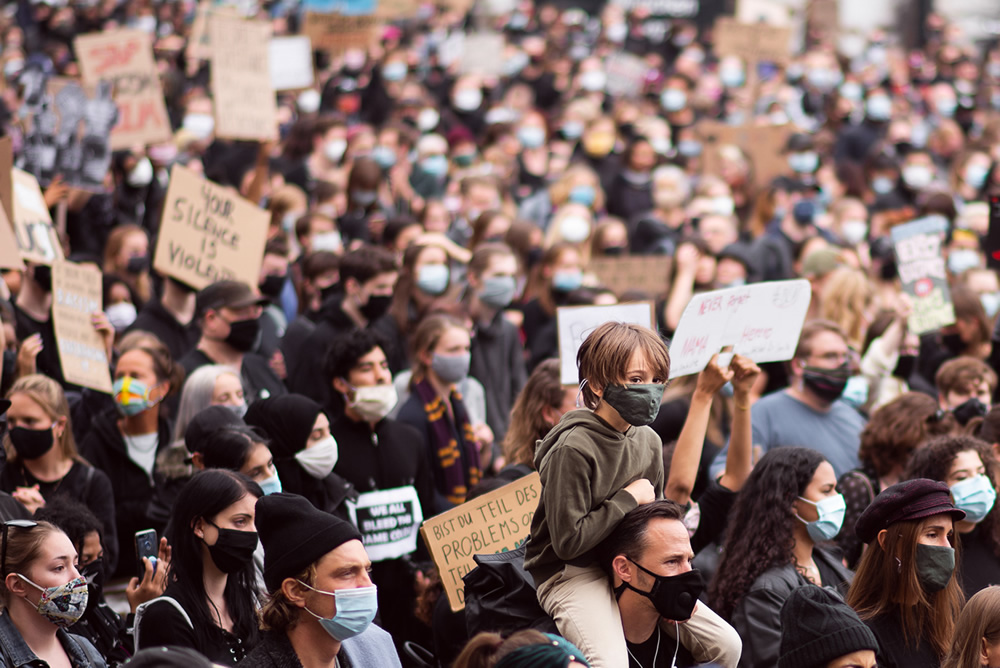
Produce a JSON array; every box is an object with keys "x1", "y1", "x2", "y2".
[{"x1": 576, "y1": 322, "x2": 670, "y2": 410}]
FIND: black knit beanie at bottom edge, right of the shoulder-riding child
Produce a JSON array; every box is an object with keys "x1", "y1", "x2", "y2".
[{"x1": 778, "y1": 585, "x2": 878, "y2": 668}]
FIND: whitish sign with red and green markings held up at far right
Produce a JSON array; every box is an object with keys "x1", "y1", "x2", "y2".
[{"x1": 890, "y1": 216, "x2": 955, "y2": 334}]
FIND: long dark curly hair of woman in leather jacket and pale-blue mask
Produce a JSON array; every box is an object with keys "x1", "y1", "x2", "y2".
[{"x1": 708, "y1": 447, "x2": 826, "y2": 619}]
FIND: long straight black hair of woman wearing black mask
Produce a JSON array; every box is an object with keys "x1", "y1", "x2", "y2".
[{"x1": 166, "y1": 469, "x2": 264, "y2": 651}]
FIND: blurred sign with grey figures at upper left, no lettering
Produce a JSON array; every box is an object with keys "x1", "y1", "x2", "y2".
[{"x1": 19, "y1": 77, "x2": 118, "y2": 192}]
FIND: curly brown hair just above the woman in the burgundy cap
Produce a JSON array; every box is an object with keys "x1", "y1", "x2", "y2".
[{"x1": 858, "y1": 392, "x2": 957, "y2": 476}]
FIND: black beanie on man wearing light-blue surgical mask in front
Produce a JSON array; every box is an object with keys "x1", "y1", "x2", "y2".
[{"x1": 254, "y1": 494, "x2": 361, "y2": 593}]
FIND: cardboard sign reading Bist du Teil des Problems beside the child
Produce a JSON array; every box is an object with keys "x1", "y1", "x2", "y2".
[{"x1": 420, "y1": 473, "x2": 542, "y2": 612}]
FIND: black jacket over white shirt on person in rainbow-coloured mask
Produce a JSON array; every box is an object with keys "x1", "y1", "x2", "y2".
[{"x1": 80, "y1": 411, "x2": 170, "y2": 575}]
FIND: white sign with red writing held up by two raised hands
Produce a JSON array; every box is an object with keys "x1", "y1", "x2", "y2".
[{"x1": 670, "y1": 279, "x2": 811, "y2": 378}]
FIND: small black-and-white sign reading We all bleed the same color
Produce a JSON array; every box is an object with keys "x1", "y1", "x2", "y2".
[{"x1": 347, "y1": 485, "x2": 424, "y2": 561}]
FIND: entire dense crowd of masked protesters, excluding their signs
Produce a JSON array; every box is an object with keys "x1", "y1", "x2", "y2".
[{"x1": 0, "y1": 0, "x2": 1000, "y2": 668}]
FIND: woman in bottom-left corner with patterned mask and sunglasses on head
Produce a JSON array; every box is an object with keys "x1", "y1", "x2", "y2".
[{"x1": 0, "y1": 520, "x2": 106, "y2": 668}]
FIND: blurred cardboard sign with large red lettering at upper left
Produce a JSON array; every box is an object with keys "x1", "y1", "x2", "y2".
[{"x1": 73, "y1": 30, "x2": 173, "y2": 151}]
